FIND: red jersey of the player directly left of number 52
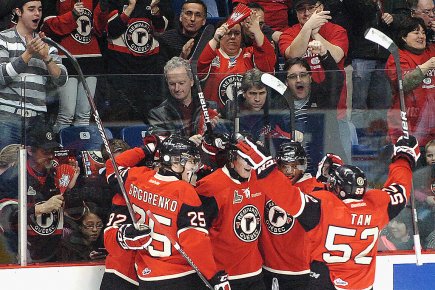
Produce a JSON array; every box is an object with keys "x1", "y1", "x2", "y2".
[{"x1": 259, "y1": 174, "x2": 323, "y2": 275}]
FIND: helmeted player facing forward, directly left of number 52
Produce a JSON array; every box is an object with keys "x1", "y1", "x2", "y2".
[{"x1": 259, "y1": 141, "x2": 324, "y2": 290}]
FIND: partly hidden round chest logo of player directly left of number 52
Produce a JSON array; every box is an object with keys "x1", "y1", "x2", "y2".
[{"x1": 264, "y1": 200, "x2": 295, "y2": 235}]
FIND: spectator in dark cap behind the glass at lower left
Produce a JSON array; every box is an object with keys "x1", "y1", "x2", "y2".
[{"x1": 0, "y1": 125, "x2": 80, "y2": 262}]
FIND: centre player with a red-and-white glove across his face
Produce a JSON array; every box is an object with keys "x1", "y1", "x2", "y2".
[{"x1": 197, "y1": 138, "x2": 305, "y2": 290}]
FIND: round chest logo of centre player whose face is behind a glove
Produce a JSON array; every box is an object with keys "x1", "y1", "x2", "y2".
[{"x1": 233, "y1": 205, "x2": 261, "y2": 243}]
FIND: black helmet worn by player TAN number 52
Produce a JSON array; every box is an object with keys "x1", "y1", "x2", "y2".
[{"x1": 329, "y1": 165, "x2": 367, "y2": 199}]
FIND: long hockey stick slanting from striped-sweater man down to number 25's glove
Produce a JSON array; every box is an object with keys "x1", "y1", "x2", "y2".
[{"x1": 42, "y1": 37, "x2": 139, "y2": 229}]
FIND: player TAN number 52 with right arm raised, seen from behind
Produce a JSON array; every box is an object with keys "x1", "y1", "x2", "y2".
[{"x1": 298, "y1": 136, "x2": 420, "y2": 290}]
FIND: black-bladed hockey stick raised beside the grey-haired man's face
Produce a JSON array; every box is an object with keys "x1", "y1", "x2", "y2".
[{"x1": 190, "y1": 24, "x2": 214, "y2": 135}]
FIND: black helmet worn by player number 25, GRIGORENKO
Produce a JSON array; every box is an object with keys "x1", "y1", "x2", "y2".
[{"x1": 159, "y1": 135, "x2": 201, "y2": 166}]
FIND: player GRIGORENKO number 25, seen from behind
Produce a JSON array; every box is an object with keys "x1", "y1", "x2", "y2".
[{"x1": 105, "y1": 135, "x2": 230, "y2": 290}]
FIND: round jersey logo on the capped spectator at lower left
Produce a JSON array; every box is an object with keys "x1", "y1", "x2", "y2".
[{"x1": 29, "y1": 201, "x2": 63, "y2": 236}]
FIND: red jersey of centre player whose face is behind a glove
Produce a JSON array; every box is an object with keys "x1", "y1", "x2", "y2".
[{"x1": 197, "y1": 167, "x2": 304, "y2": 280}]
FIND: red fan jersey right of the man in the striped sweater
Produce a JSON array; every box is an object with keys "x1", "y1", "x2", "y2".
[{"x1": 41, "y1": 0, "x2": 101, "y2": 57}]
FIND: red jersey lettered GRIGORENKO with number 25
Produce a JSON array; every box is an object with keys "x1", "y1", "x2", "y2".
[{"x1": 105, "y1": 148, "x2": 217, "y2": 281}]
